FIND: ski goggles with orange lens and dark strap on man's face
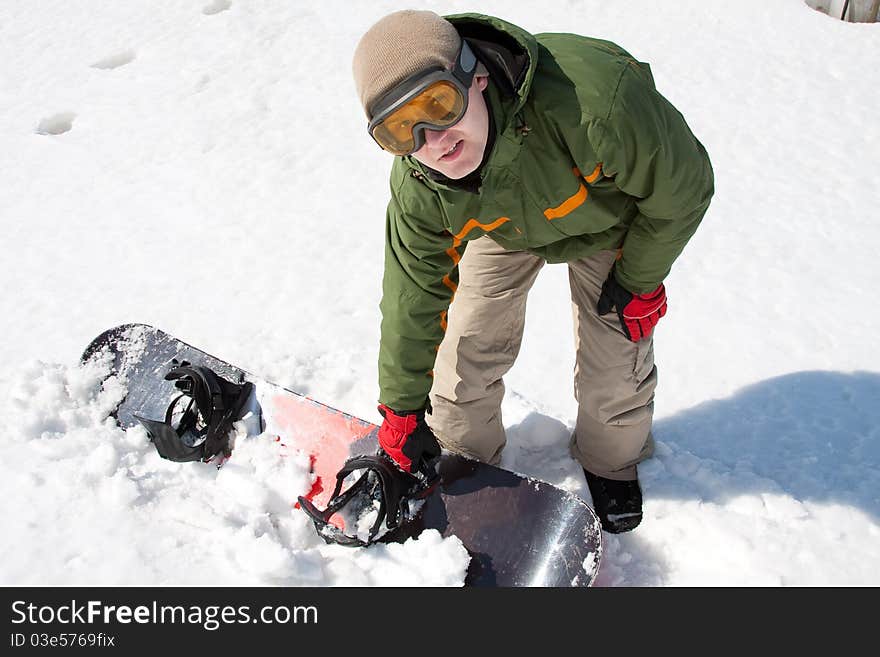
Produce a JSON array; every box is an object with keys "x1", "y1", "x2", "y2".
[{"x1": 367, "y1": 39, "x2": 477, "y2": 155}]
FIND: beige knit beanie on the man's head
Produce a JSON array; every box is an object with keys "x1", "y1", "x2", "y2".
[{"x1": 352, "y1": 9, "x2": 461, "y2": 118}]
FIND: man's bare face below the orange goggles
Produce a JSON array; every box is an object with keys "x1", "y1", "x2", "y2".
[{"x1": 413, "y1": 75, "x2": 489, "y2": 180}]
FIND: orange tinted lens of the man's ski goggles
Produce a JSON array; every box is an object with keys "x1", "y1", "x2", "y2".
[{"x1": 372, "y1": 80, "x2": 465, "y2": 155}]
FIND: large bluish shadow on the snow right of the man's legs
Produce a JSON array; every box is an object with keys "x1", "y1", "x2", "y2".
[{"x1": 646, "y1": 371, "x2": 880, "y2": 519}]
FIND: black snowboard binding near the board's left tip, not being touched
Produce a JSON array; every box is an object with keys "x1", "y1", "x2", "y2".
[{"x1": 132, "y1": 360, "x2": 254, "y2": 463}]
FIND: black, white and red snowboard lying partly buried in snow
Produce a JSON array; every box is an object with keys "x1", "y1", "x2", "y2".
[{"x1": 82, "y1": 324, "x2": 602, "y2": 587}]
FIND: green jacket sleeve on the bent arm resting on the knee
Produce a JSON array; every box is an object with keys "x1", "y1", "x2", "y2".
[{"x1": 594, "y1": 60, "x2": 714, "y2": 294}]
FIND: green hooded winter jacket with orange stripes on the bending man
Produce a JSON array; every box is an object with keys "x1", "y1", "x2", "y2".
[{"x1": 379, "y1": 14, "x2": 713, "y2": 411}]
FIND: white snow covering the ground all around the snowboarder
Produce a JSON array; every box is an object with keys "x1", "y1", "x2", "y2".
[{"x1": 0, "y1": 0, "x2": 880, "y2": 586}]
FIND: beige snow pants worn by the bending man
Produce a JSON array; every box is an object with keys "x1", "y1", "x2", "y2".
[{"x1": 426, "y1": 236, "x2": 657, "y2": 480}]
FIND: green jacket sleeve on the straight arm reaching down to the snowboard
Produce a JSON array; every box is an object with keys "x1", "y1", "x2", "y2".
[{"x1": 379, "y1": 190, "x2": 464, "y2": 412}]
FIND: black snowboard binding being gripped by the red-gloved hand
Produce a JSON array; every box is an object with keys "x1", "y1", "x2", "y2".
[{"x1": 298, "y1": 450, "x2": 439, "y2": 547}]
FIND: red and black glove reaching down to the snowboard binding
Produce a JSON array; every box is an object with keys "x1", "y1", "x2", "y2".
[{"x1": 379, "y1": 404, "x2": 440, "y2": 474}]
